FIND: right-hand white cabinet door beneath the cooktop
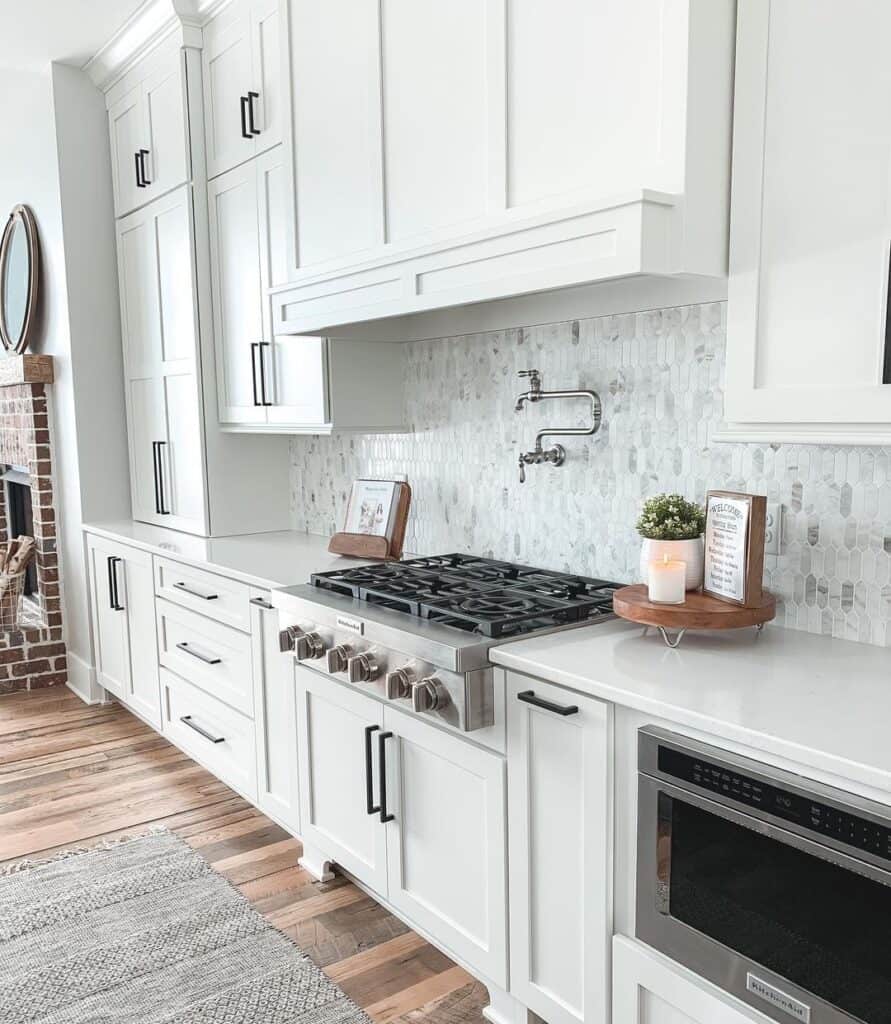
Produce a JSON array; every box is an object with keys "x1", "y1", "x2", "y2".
[{"x1": 384, "y1": 708, "x2": 507, "y2": 987}]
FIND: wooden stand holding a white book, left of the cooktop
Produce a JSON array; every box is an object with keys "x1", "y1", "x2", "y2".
[{"x1": 328, "y1": 480, "x2": 412, "y2": 558}]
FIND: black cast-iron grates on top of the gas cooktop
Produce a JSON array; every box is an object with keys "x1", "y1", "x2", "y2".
[{"x1": 310, "y1": 554, "x2": 622, "y2": 638}]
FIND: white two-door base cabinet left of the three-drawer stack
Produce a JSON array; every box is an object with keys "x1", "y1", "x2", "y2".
[{"x1": 87, "y1": 535, "x2": 161, "y2": 729}]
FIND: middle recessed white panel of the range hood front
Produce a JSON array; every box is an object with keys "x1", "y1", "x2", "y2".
[{"x1": 381, "y1": 0, "x2": 487, "y2": 241}]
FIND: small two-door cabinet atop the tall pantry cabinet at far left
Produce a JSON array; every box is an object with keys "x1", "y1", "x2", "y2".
[{"x1": 107, "y1": 40, "x2": 190, "y2": 217}]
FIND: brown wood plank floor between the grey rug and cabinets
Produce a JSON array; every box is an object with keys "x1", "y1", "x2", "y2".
[{"x1": 0, "y1": 688, "x2": 489, "y2": 1024}]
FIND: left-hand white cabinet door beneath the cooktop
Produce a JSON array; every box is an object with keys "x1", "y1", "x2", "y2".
[{"x1": 294, "y1": 665, "x2": 387, "y2": 894}]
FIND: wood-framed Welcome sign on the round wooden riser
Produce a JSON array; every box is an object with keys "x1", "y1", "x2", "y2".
[{"x1": 703, "y1": 490, "x2": 767, "y2": 607}]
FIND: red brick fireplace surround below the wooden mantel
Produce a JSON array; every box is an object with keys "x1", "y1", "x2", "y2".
[{"x1": 0, "y1": 384, "x2": 68, "y2": 693}]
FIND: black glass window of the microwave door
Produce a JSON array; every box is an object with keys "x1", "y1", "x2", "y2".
[{"x1": 659, "y1": 792, "x2": 891, "y2": 1024}]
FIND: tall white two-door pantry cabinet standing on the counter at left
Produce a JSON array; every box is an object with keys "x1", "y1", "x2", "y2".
[{"x1": 117, "y1": 186, "x2": 207, "y2": 534}]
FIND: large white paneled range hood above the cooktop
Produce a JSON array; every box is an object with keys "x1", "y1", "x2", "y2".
[{"x1": 272, "y1": 0, "x2": 735, "y2": 333}]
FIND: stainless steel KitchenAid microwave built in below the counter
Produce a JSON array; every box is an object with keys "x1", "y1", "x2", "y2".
[{"x1": 636, "y1": 728, "x2": 891, "y2": 1024}]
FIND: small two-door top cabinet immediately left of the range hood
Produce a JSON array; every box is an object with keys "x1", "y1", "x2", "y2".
[{"x1": 202, "y1": 0, "x2": 285, "y2": 178}]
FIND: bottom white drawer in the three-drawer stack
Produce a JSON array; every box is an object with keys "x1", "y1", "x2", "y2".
[{"x1": 161, "y1": 669, "x2": 257, "y2": 802}]
